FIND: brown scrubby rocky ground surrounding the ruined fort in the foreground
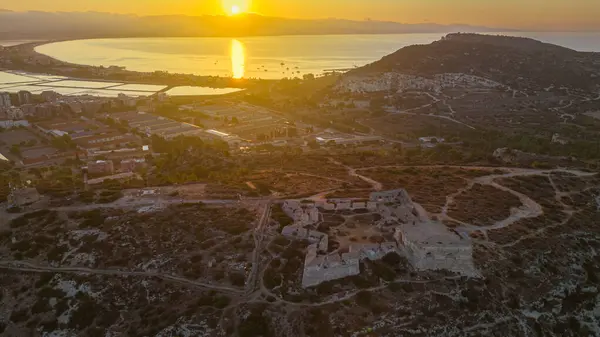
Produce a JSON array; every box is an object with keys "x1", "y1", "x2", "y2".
[{"x1": 0, "y1": 163, "x2": 600, "y2": 337}]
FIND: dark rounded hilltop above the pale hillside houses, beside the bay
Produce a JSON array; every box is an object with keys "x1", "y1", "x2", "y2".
[{"x1": 347, "y1": 33, "x2": 600, "y2": 92}]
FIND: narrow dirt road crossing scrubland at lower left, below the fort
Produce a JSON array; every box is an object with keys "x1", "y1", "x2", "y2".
[{"x1": 0, "y1": 260, "x2": 242, "y2": 293}]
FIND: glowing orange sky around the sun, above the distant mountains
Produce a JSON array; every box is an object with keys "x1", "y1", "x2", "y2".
[{"x1": 0, "y1": 0, "x2": 600, "y2": 31}]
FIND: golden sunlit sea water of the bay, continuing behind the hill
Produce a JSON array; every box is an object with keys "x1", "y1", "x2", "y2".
[{"x1": 36, "y1": 32, "x2": 600, "y2": 79}]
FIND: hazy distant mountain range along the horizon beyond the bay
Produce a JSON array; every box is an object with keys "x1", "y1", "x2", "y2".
[{"x1": 0, "y1": 9, "x2": 509, "y2": 39}]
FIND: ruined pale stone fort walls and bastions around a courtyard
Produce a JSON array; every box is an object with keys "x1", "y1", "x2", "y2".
[{"x1": 282, "y1": 189, "x2": 478, "y2": 288}]
